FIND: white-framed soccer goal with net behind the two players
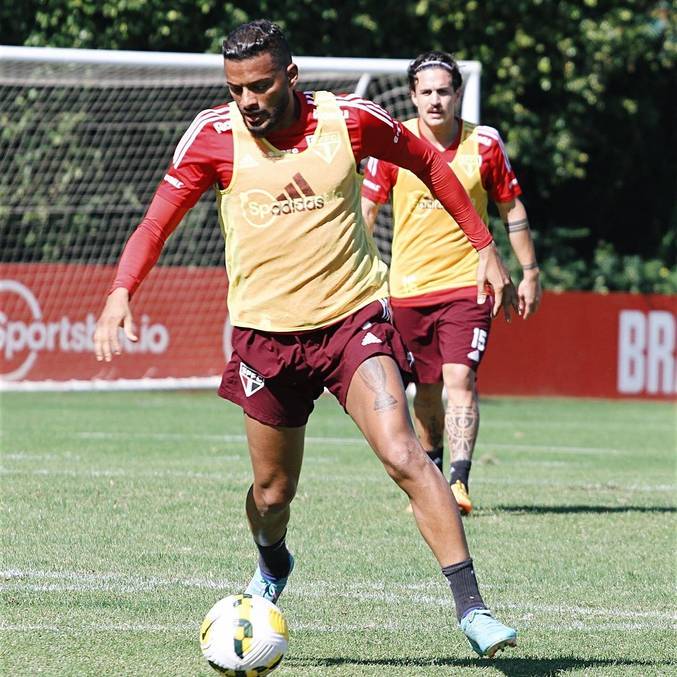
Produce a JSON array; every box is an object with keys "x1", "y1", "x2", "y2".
[{"x1": 0, "y1": 46, "x2": 481, "y2": 389}]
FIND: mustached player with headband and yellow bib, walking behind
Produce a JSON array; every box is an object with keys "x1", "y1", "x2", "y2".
[{"x1": 362, "y1": 51, "x2": 541, "y2": 514}]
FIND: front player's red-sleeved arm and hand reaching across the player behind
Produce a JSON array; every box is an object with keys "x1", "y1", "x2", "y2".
[{"x1": 362, "y1": 116, "x2": 517, "y2": 321}]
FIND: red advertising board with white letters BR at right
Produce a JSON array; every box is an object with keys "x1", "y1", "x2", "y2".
[{"x1": 479, "y1": 292, "x2": 677, "y2": 399}]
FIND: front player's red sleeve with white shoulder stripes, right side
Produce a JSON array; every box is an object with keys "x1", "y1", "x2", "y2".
[{"x1": 339, "y1": 96, "x2": 493, "y2": 249}]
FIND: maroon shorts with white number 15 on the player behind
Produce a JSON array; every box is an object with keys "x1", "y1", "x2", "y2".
[{"x1": 393, "y1": 296, "x2": 493, "y2": 383}]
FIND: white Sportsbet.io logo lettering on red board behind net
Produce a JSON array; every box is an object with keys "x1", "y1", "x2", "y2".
[{"x1": 0, "y1": 280, "x2": 170, "y2": 381}]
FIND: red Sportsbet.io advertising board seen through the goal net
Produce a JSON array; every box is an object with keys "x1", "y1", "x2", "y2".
[{"x1": 0, "y1": 264, "x2": 227, "y2": 382}]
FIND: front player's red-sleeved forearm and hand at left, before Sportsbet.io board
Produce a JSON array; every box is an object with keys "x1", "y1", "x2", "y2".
[{"x1": 94, "y1": 194, "x2": 190, "y2": 362}]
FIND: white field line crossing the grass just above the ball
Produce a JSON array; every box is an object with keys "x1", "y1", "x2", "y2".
[{"x1": 0, "y1": 569, "x2": 677, "y2": 622}]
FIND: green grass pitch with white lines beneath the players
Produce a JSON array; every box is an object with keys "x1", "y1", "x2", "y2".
[{"x1": 0, "y1": 393, "x2": 677, "y2": 677}]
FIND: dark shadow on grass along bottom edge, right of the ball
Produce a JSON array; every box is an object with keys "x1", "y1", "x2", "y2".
[{"x1": 286, "y1": 656, "x2": 674, "y2": 677}]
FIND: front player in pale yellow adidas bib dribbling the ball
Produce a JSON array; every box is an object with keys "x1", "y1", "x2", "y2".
[{"x1": 95, "y1": 20, "x2": 516, "y2": 656}]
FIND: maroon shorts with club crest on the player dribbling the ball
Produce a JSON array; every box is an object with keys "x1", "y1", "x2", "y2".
[{"x1": 219, "y1": 301, "x2": 413, "y2": 427}]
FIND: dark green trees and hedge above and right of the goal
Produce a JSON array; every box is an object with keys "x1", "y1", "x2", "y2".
[{"x1": 0, "y1": 0, "x2": 677, "y2": 291}]
